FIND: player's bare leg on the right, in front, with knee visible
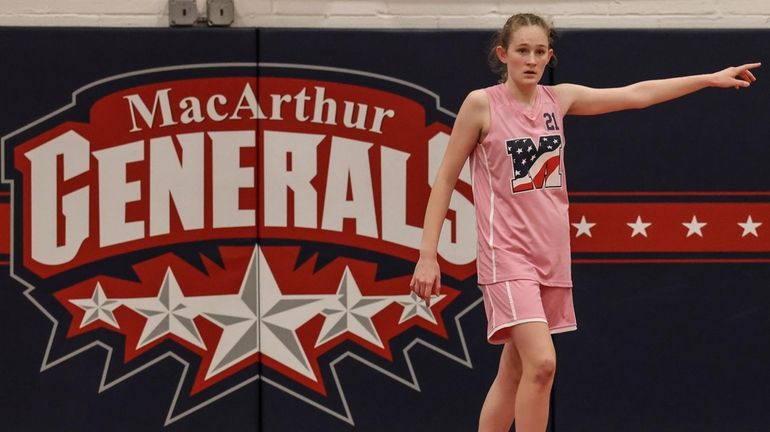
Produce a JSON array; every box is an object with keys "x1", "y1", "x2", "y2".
[{"x1": 511, "y1": 322, "x2": 556, "y2": 432}]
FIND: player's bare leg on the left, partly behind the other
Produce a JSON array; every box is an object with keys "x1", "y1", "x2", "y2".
[{"x1": 479, "y1": 342, "x2": 521, "y2": 432}]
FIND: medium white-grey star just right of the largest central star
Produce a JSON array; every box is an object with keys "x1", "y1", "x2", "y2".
[{"x1": 315, "y1": 267, "x2": 393, "y2": 348}]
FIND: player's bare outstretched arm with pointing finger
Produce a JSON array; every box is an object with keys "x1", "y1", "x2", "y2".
[{"x1": 554, "y1": 63, "x2": 761, "y2": 115}]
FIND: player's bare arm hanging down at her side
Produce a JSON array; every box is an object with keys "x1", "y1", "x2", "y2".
[{"x1": 409, "y1": 90, "x2": 489, "y2": 306}]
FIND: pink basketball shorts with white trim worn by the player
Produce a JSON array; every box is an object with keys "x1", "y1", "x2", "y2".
[{"x1": 479, "y1": 279, "x2": 577, "y2": 345}]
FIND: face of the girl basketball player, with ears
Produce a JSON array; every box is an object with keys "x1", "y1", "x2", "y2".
[{"x1": 497, "y1": 25, "x2": 553, "y2": 86}]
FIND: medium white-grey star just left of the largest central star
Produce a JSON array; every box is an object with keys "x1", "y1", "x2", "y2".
[{"x1": 121, "y1": 268, "x2": 206, "y2": 349}]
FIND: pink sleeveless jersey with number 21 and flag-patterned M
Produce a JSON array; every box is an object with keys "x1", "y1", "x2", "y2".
[{"x1": 470, "y1": 84, "x2": 572, "y2": 287}]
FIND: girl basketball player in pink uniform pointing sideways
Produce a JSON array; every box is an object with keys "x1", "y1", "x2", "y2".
[{"x1": 410, "y1": 14, "x2": 760, "y2": 432}]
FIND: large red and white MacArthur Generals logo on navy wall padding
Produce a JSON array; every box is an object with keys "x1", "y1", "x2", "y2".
[{"x1": 3, "y1": 64, "x2": 480, "y2": 424}]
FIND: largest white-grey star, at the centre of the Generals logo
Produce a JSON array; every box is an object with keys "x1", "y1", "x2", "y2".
[{"x1": 200, "y1": 246, "x2": 329, "y2": 381}]
